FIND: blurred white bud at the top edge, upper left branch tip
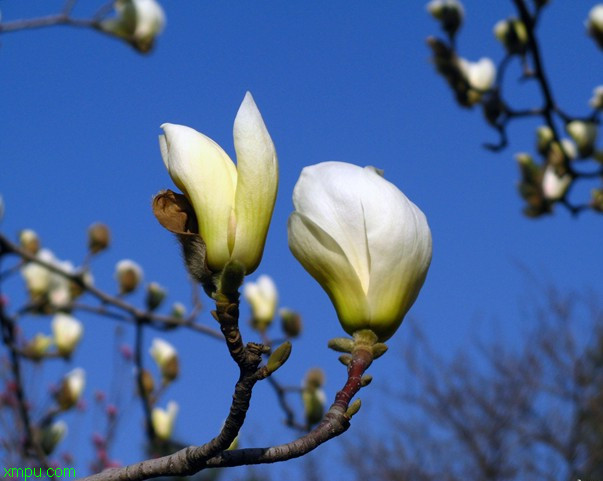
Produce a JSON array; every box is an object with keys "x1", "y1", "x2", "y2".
[{"x1": 100, "y1": 0, "x2": 165, "y2": 53}]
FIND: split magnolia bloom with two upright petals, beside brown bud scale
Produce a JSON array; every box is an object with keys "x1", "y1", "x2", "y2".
[{"x1": 159, "y1": 92, "x2": 278, "y2": 274}]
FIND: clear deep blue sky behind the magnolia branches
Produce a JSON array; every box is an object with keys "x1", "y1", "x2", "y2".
[{"x1": 0, "y1": 0, "x2": 603, "y2": 474}]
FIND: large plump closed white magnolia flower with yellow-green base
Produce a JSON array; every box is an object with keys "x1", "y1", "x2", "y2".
[{"x1": 288, "y1": 162, "x2": 432, "y2": 340}]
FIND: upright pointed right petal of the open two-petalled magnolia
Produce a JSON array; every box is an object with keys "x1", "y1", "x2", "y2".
[{"x1": 232, "y1": 92, "x2": 278, "y2": 274}]
